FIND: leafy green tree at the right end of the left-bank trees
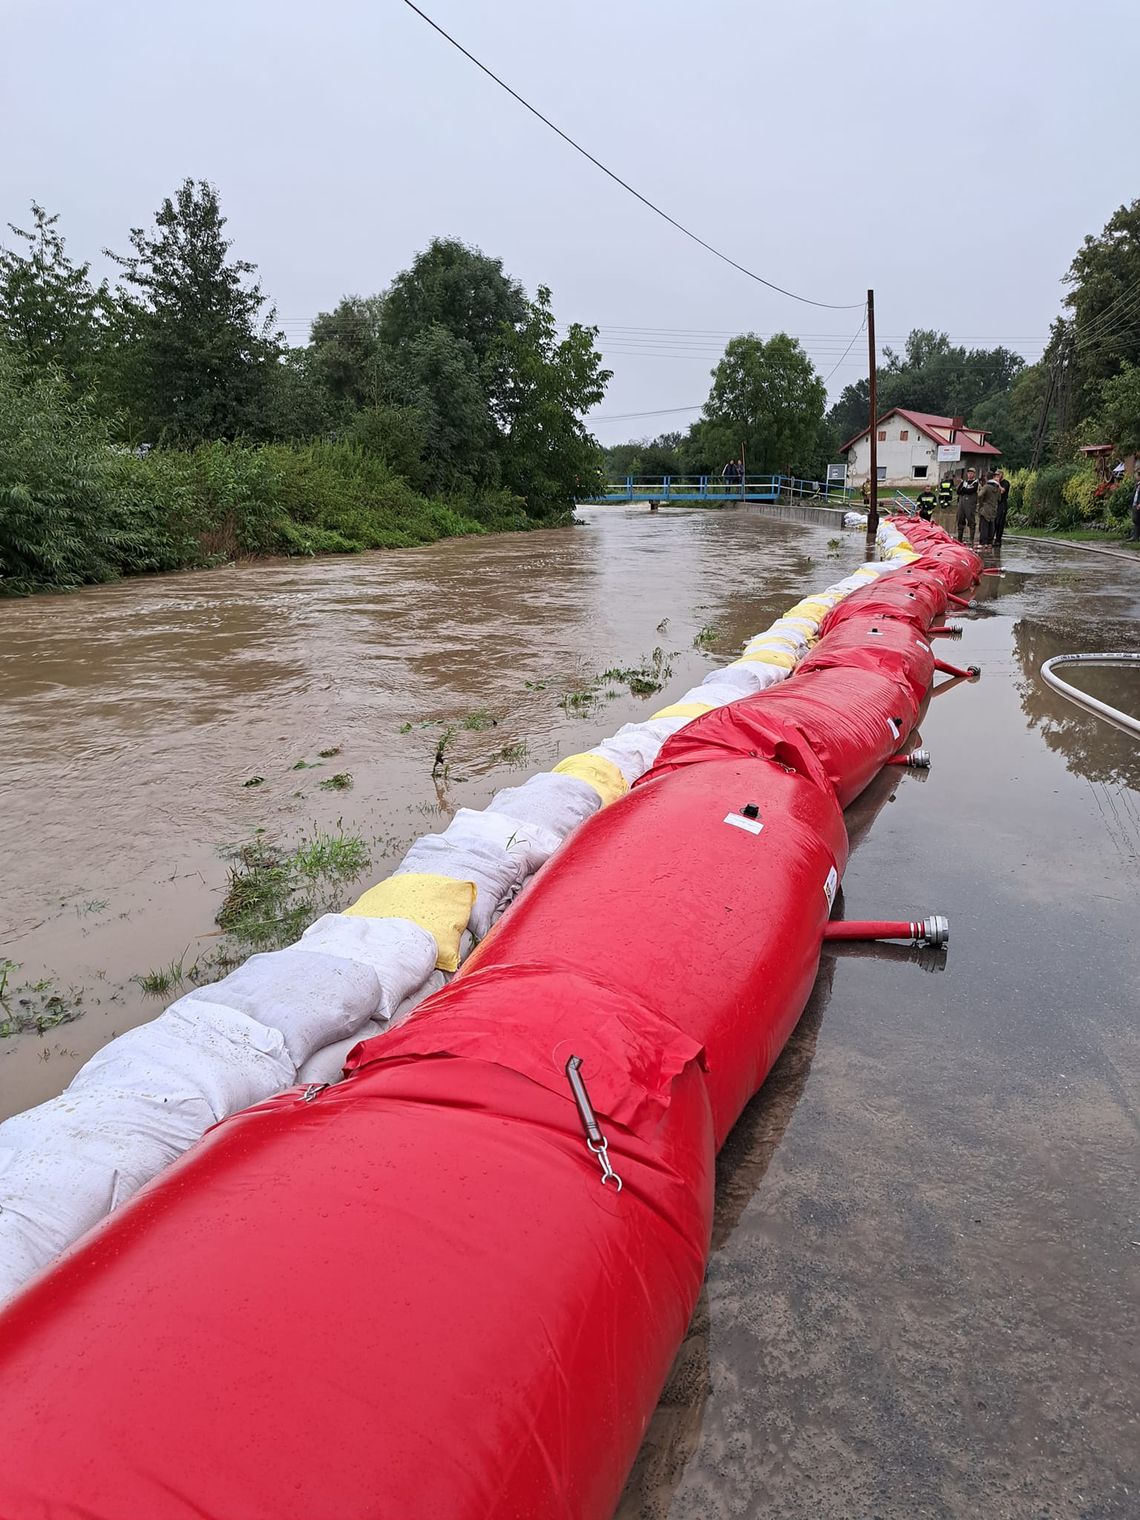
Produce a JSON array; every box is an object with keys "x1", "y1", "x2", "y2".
[{"x1": 488, "y1": 286, "x2": 613, "y2": 518}]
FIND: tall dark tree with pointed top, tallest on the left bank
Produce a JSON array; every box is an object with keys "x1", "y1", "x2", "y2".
[{"x1": 106, "y1": 179, "x2": 281, "y2": 444}]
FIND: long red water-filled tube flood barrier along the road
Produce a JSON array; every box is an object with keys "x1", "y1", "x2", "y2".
[{"x1": 0, "y1": 524, "x2": 971, "y2": 1520}]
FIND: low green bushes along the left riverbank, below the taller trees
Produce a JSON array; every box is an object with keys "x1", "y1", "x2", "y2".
[{"x1": 0, "y1": 354, "x2": 534, "y2": 594}]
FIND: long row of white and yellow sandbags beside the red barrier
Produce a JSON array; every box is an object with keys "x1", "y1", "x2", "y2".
[{"x1": 0, "y1": 564, "x2": 912, "y2": 1301}]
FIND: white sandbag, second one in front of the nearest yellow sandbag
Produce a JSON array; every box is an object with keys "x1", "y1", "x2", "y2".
[{"x1": 173, "y1": 941, "x2": 383, "y2": 1067}]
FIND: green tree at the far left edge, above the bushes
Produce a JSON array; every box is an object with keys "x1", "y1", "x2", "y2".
[{"x1": 0, "y1": 201, "x2": 108, "y2": 395}]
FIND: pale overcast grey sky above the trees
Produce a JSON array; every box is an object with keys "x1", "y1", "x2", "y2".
[{"x1": 0, "y1": 0, "x2": 1140, "y2": 442}]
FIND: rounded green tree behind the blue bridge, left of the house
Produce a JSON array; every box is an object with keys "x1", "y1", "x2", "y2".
[{"x1": 702, "y1": 333, "x2": 827, "y2": 474}]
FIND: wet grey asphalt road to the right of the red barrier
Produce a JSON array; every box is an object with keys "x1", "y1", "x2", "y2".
[{"x1": 619, "y1": 541, "x2": 1140, "y2": 1520}]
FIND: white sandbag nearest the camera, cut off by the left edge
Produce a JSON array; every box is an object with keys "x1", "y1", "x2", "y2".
[{"x1": 0, "y1": 1143, "x2": 116, "y2": 1303}]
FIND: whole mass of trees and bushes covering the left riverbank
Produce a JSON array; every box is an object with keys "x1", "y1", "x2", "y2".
[{"x1": 0, "y1": 179, "x2": 610, "y2": 593}]
